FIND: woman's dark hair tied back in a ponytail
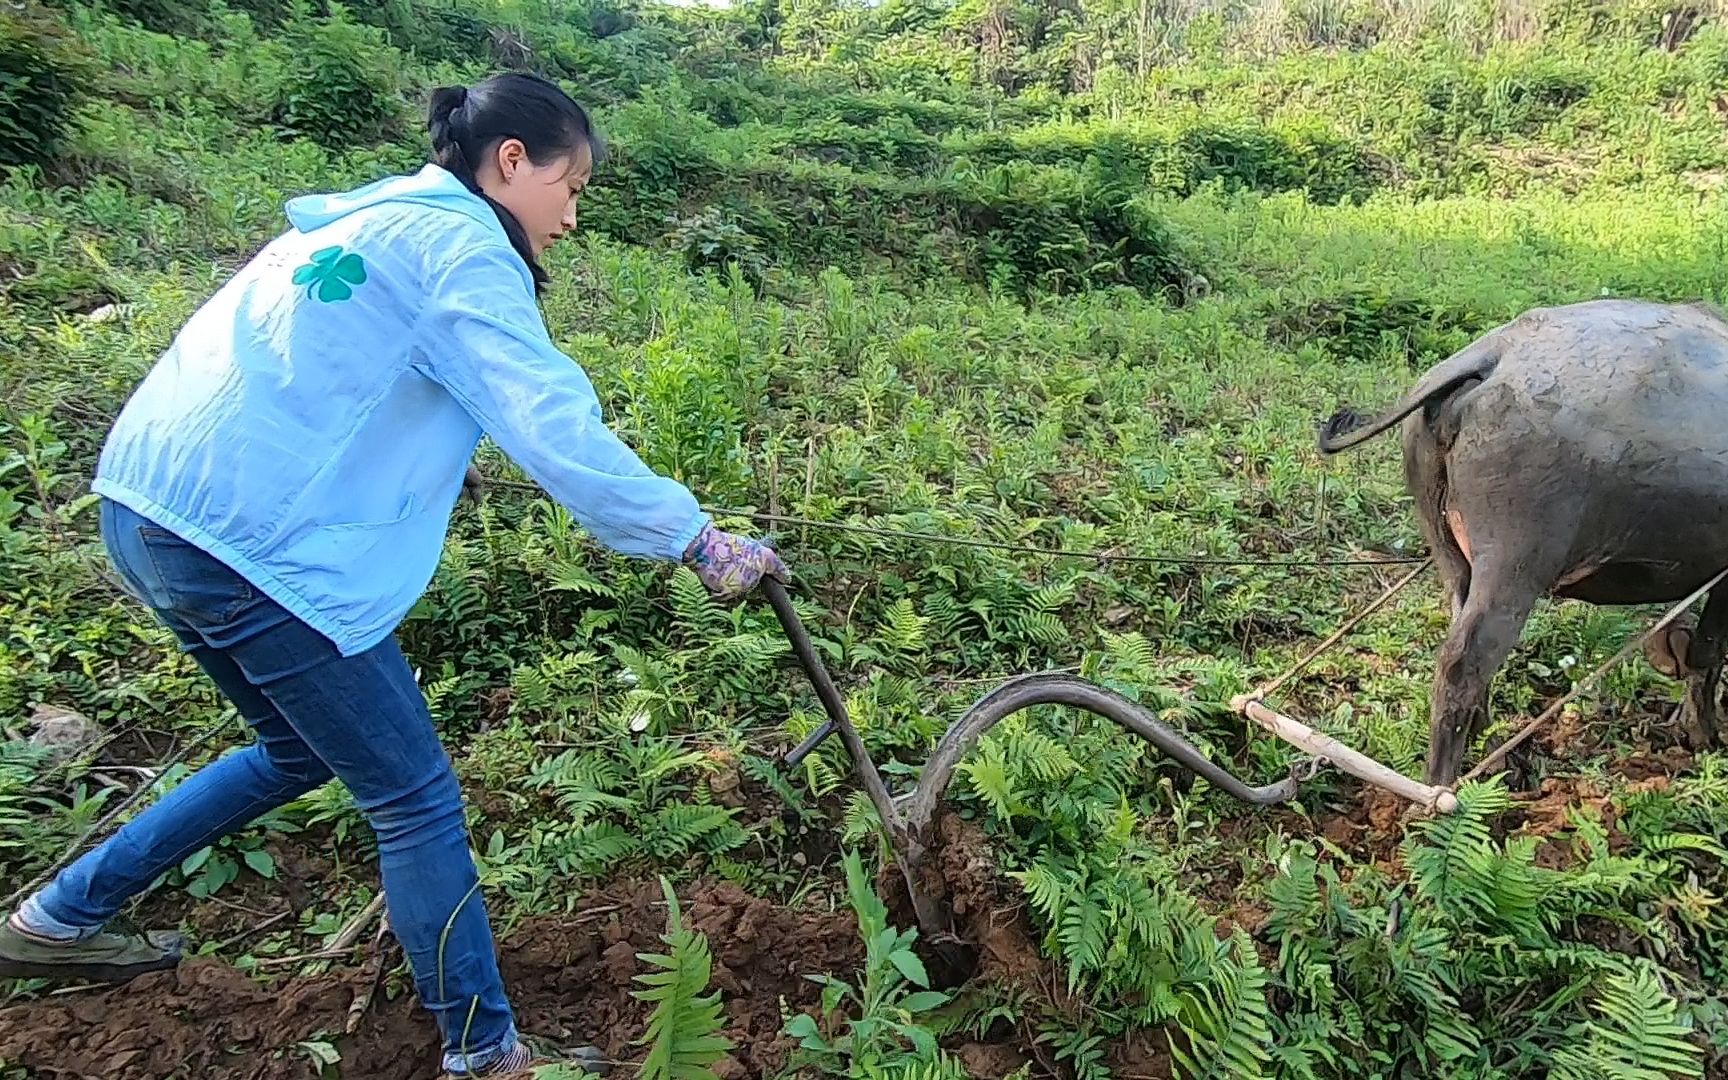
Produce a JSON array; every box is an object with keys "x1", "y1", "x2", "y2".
[{"x1": 427, "y1": 73, "x2": 605, "y2": 290}]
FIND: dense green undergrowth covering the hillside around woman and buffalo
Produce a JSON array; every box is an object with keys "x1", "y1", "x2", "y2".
[{"x1": 0, "y1": 0, "x2": 1728, "y2": 1078}]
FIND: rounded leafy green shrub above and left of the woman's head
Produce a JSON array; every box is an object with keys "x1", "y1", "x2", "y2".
[{"x1": 271, "y1": 3, "x2": 401, "y2": 149}]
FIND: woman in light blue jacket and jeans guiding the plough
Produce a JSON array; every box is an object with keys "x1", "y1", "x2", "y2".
[{"x1": 0, "y1": 74, "x2": 786, "y2": 1075}]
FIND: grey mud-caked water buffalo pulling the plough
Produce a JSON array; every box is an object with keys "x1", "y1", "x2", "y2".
[{"x1": 1320, "y1": 299, "x2": 1728, "y2": 785}]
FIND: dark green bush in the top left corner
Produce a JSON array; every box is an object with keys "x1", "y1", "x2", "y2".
[{"x1": 0, "y1": 3, "x2": 90, "y2": 166}]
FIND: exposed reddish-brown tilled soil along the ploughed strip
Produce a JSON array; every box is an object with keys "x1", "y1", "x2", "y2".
[{"x1": 0, "y1": 739, "x2": 1685, "y2": 1080}]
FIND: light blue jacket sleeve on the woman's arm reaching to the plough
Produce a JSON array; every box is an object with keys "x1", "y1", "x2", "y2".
[{"x1": 416, "y1": 242, "x2": 708, "y2": 562}]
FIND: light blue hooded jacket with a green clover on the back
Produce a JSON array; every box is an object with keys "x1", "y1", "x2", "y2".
[{"x1": 93, "y1": 166, "x2": 708, "y2": 655}]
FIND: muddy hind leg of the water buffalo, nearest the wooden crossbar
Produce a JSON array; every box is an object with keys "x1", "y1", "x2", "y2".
[{"x1": 1427, "y1": 565, "x2": 1541, "y2": 785}]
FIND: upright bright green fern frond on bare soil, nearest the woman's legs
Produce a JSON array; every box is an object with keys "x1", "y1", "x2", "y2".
[{"x1": 631, "y1": 878, "x2": 733, "y2": 1080}]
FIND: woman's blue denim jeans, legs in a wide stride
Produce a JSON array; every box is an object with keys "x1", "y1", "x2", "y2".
[{"x1": 31, "y1": 499, "x2": 517, "y2": 1071}]
